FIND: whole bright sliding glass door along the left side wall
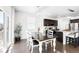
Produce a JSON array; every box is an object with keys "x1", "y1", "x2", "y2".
[{"x1": 0, "y1": 10, "x2": 10, "y2": 52}]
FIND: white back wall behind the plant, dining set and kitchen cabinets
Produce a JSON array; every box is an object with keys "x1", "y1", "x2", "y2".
[{"x1": 15, "y1": 11, "x2": 78, "y2": 39}]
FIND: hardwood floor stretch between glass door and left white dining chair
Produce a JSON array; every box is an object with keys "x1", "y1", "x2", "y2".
[{"x1": 11, "y1": 40, "x2": 30, "y2": 53}]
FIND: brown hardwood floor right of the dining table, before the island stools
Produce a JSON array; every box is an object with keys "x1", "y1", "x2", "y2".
[{"x1": 56, "y1": 42, "x2": 79, "y2": 53}]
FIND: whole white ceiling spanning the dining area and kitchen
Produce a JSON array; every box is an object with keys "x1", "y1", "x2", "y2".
[{"x1": 14, "y1": 6, "x2": 79, "y2": 17}]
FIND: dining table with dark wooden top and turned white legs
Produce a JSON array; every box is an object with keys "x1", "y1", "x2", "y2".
[{"x1": 34, "y1": 36, "x2": 56, "y2": 53}]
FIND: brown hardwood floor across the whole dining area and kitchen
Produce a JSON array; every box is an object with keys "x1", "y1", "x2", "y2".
[{"x1": 8, "y1": 40, "x2": 79, "y2": 53}]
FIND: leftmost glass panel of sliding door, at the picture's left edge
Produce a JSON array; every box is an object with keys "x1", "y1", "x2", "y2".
[{"x1": 0, "y1": 10, "x2": 4, "y2": 52}]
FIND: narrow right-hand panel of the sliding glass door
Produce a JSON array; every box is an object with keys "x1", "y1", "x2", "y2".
[{"x1": 3, "y1": 13, "x2": 10, "y2": 51}]
